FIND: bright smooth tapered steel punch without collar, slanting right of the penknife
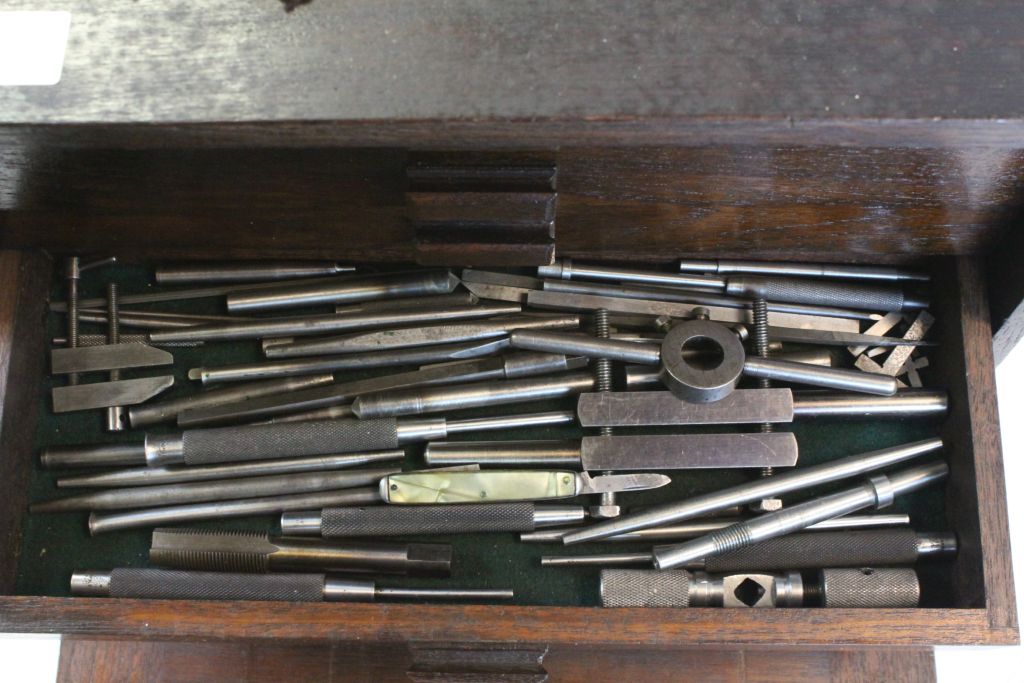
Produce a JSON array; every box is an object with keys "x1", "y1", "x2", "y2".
[{"x1": 563, "y1": 438, "x2": 942, "y2": 545}]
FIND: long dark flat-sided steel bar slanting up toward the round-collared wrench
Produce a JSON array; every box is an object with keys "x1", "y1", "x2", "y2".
[{"x1": 178, "y1": 352, "x2": 587, "y2": 427}]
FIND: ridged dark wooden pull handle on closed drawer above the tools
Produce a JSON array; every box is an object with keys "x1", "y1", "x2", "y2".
[{"x1": 406, "y1": 154, "x2": 558, "y2": 266}]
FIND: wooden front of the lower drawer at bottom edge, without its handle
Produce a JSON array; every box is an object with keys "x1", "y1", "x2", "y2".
[{"x1": 57, "y1": 638, "x2": 935, "y2": 683}]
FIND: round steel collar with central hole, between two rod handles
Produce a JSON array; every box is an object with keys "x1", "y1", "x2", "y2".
[{"x1": 659, "y1": 321, "x2": 746, "y2": 403}]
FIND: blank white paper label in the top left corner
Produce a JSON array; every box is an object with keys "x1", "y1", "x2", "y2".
[{"x1": 0, "y1": 11, "x2": 71, "y2": 86}]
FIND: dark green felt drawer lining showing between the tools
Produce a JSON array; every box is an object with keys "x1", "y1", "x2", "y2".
[{"x1": 15, "y1": 265, "x2": 951, "y2": 606}]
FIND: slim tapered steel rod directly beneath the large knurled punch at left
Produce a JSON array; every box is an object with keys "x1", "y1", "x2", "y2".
[{"x1": 57, "y1": 446, "x2": 406, "y2": 488}]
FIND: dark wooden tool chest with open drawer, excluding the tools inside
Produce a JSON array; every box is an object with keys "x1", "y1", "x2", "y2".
[{"x1": 0, "y1": 0, "x2": 1024, "y2": 671}]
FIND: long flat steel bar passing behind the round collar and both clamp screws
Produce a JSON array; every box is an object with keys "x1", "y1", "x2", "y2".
[{"x1": 526, "y1": 290, "x2": 860, "y2": 334}]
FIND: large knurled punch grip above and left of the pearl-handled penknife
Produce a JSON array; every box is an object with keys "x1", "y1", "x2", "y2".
[{"x1": 181, "y1": 419, "x2": 398, "y2": 465}]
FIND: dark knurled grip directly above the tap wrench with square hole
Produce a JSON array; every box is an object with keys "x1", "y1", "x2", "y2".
[{"x1": 705, "y1": 528, "x2": 918, "y2": 572}]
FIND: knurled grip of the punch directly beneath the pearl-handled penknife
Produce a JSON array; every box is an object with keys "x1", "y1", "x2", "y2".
[{"x1": 321, "y1": 503, "x2": 534, "y2": 539}]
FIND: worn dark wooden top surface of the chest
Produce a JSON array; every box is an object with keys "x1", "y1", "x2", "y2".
[{"x1": 0, "y1": 0, "x2": 1024, "y2": 123}]
